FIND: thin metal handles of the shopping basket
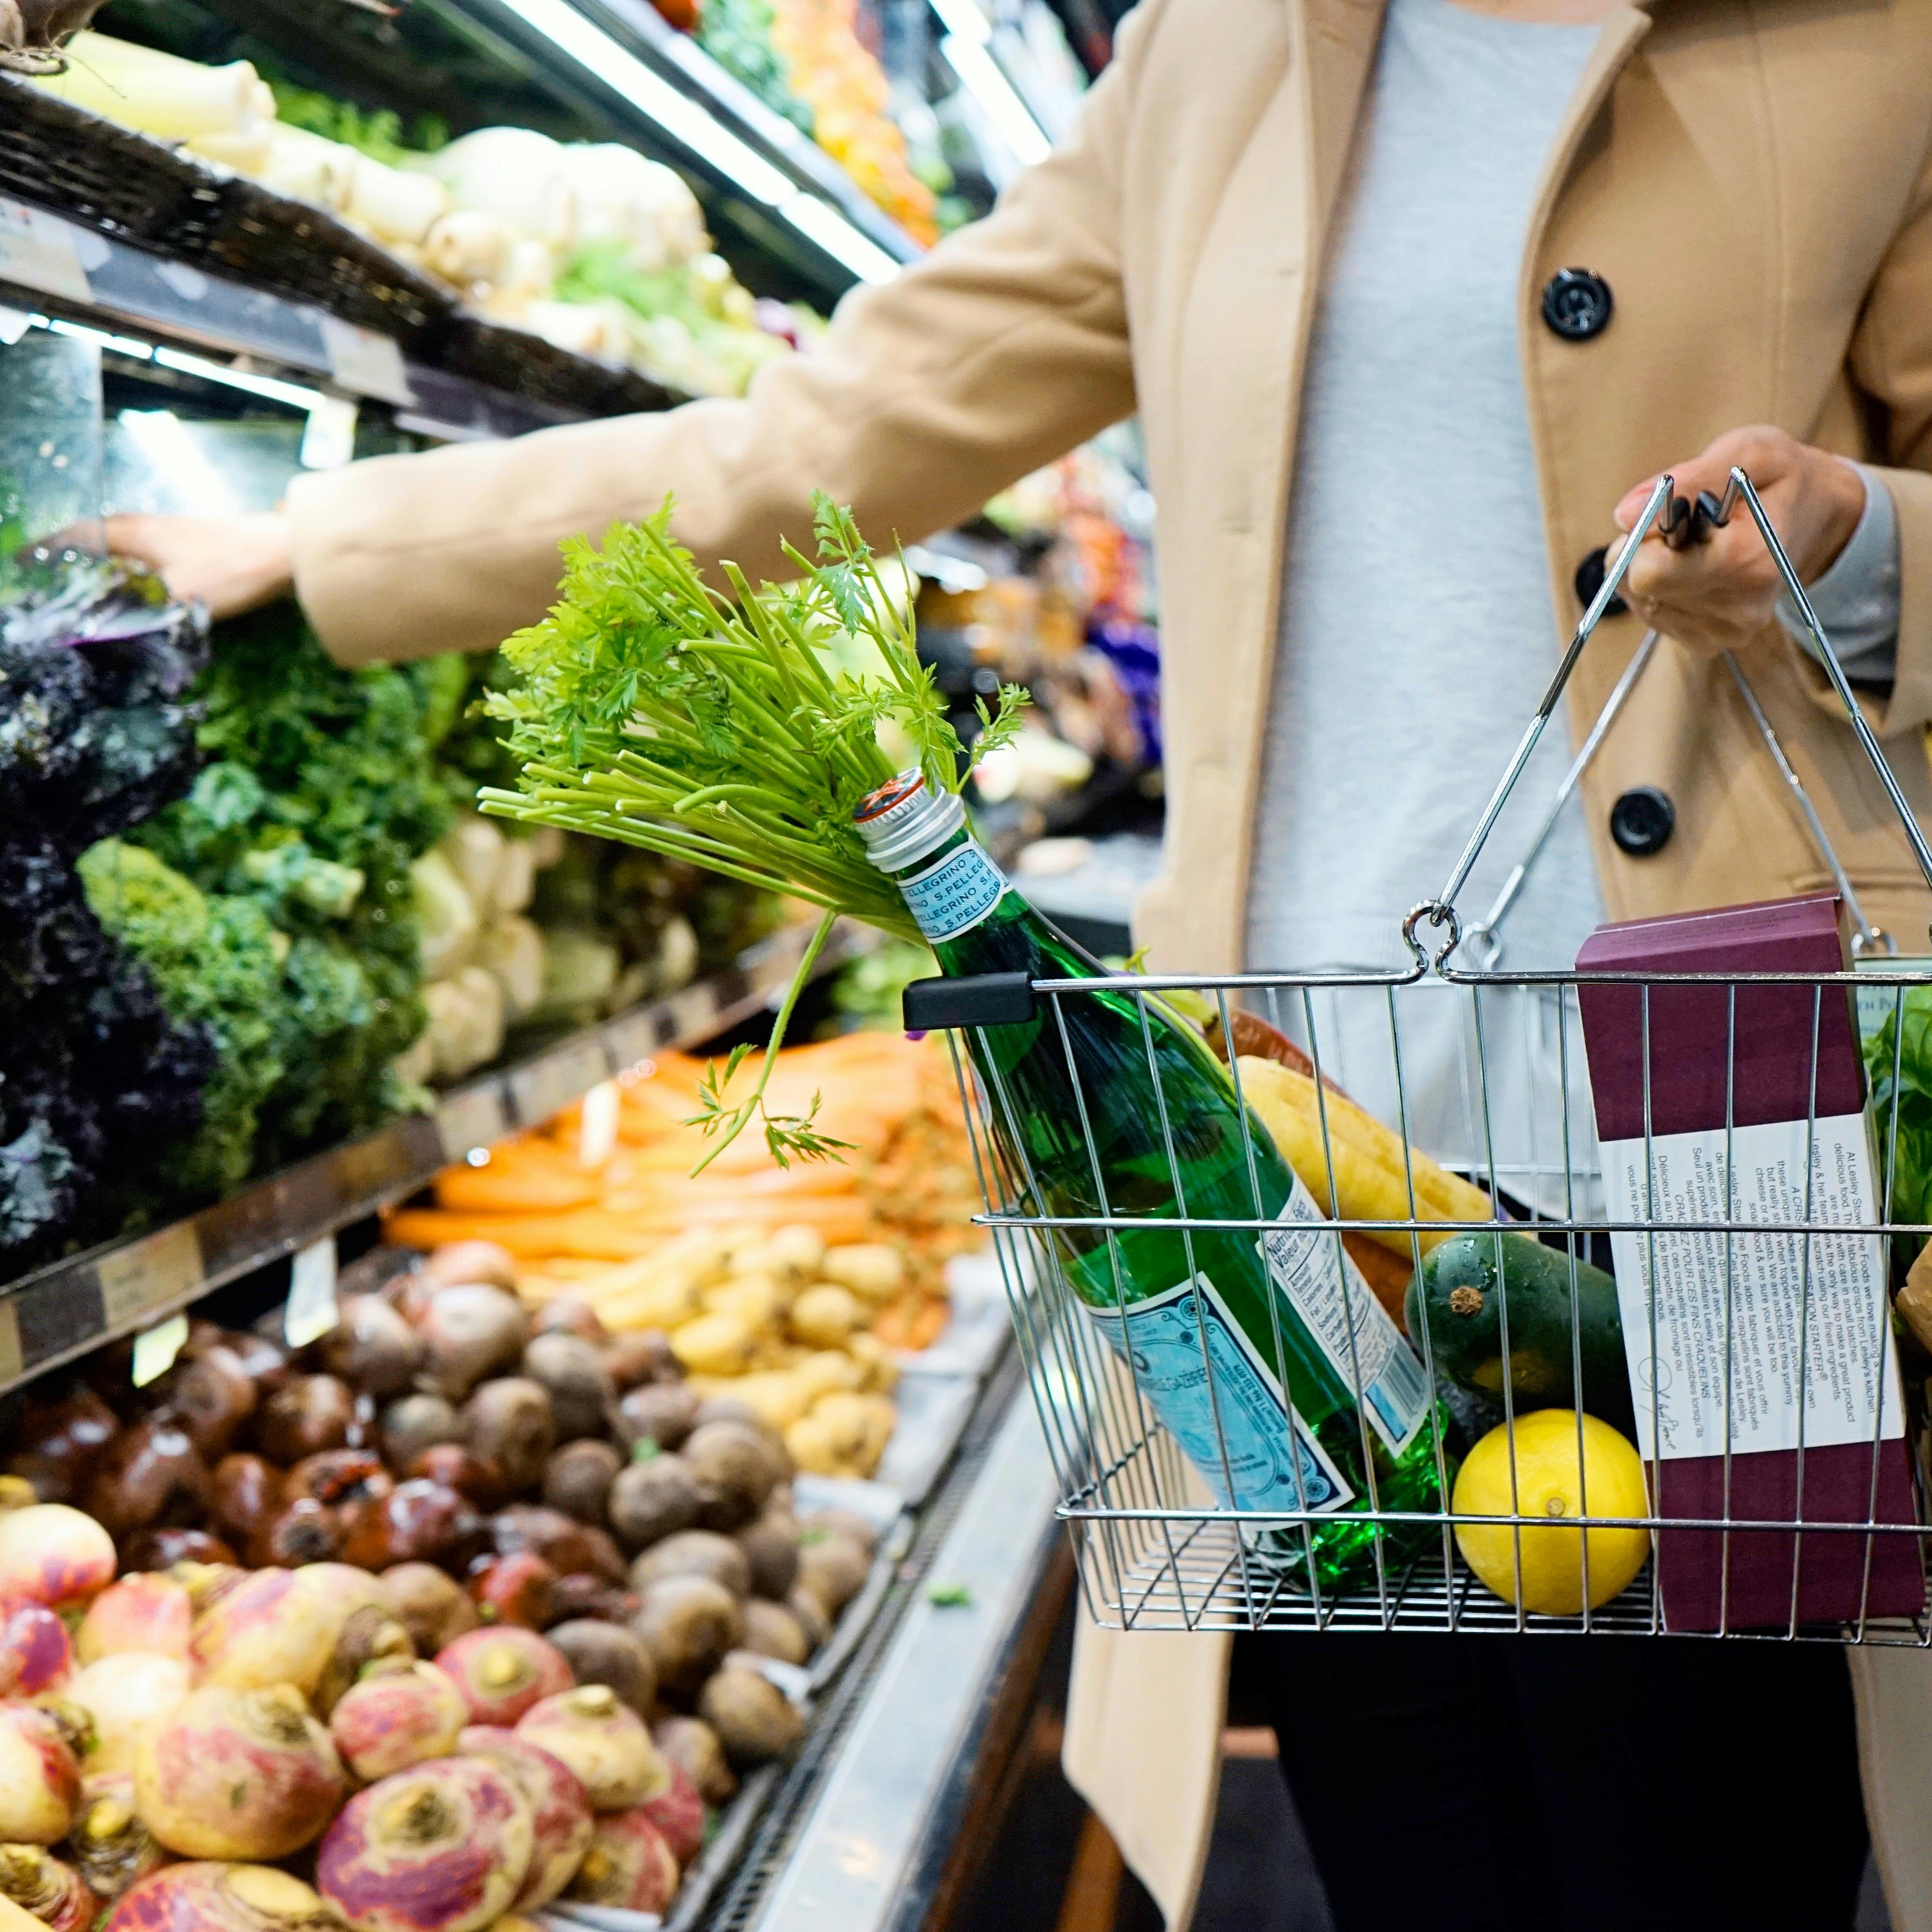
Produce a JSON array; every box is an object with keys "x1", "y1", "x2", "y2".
[{"x1": 1403, "y1": 466, "x2": 1932, "y2": 972}]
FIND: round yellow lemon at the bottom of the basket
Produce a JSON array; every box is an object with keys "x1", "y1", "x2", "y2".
[{"x1": 1449, "y1": 1408, "x2": 1650, "y2": 1617}]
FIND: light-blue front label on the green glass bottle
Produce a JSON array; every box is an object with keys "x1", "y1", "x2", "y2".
[{"x1": 1080, "y1": 1275, "x2": 1354, "y2": 1513}]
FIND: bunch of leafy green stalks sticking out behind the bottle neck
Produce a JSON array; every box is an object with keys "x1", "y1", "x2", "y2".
[{"x1": 479, "y1": 495, "x2": 1026, "y2": 1165}]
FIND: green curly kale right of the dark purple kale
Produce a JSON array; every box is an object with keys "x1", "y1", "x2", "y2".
[{"x1": 133, "y1": 605, "x2": 456, "y2": 1171}]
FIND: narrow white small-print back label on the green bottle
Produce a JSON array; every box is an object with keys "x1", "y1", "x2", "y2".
[{"x1": 1262, "y1": 1175, "x2": 1430, "y2": 1457}]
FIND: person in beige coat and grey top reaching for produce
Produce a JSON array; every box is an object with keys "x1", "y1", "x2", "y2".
[{"x1": 112, "y1": 0, "x2": 1932, "y2": 1932}]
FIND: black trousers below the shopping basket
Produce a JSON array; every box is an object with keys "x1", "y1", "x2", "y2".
[{"x1": 1231, "y1": 1634, "x2": 1866, "y2": 1932}]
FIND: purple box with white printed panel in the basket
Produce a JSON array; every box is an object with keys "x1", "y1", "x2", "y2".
[{"x1": 1577, "y1": 895, "x2": 1924, "y2": 1631}]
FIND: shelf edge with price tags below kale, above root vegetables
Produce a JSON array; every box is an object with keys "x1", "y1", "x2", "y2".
[{"x1": 0, "y1": 922, "x2": 875, "y2": 1393}]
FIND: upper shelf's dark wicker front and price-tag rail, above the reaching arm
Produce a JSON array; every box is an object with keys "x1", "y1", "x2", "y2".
[{"x1": 0, "y1": 125, "x2": 686, "y2": 435}]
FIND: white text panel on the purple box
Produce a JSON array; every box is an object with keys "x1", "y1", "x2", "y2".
[{"x1": 1604, "y1": 1113, "x2": 1905, "y2": 1461}]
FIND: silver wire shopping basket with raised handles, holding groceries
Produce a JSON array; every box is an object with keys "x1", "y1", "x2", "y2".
[{"x1": 952, "y1": 471, "x2": 1932, "y2": 1646}]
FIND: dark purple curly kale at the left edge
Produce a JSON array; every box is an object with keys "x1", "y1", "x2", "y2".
[{"x1": 0, "y1": 554, "x2": 216, "y2": 1275}]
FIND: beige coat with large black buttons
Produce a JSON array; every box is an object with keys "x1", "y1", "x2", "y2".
[{"x1": 290, "y1": 0, "x2": 1932, "y2": 1932}]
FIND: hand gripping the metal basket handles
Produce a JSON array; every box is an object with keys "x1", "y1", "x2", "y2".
[{"x1": 1617, "y1": 427, "x2": 1864, "y2": 657}]
